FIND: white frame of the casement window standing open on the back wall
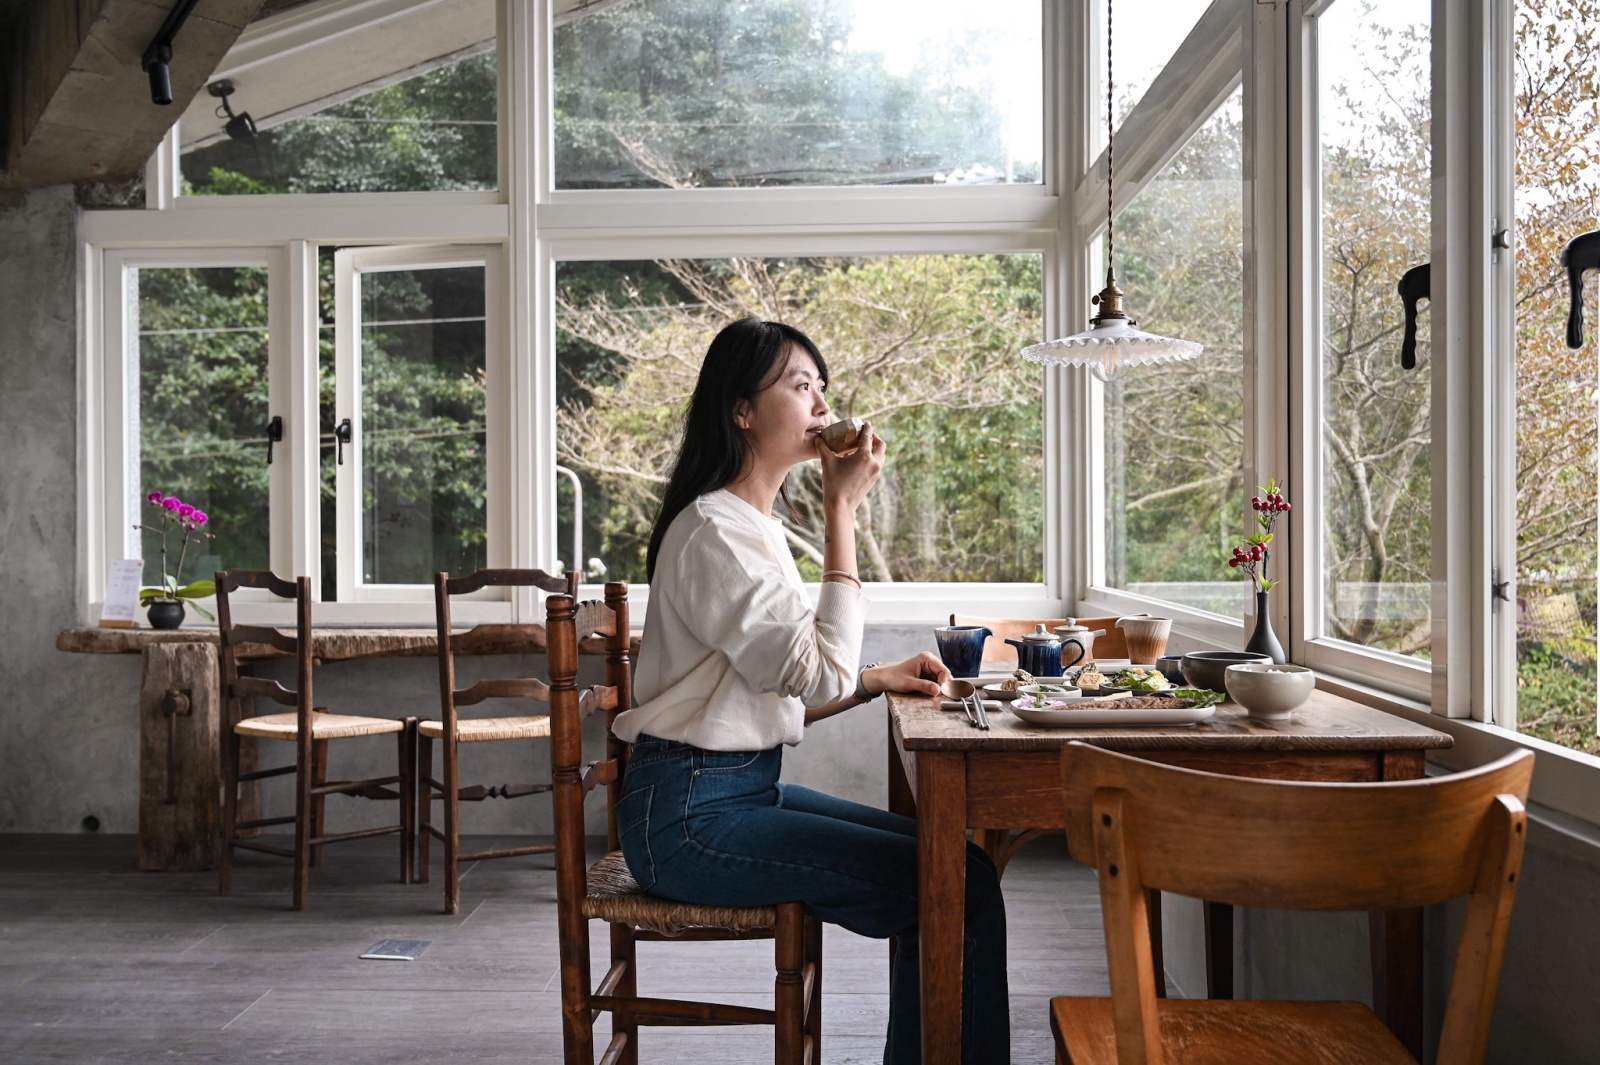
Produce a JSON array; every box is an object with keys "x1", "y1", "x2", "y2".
[{"x1": 333, "y1": 245, "x2": 510, "y2": 603}]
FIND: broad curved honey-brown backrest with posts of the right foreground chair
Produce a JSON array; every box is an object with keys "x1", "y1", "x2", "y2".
[{"x1": 1061, "y1": 742, "x2": 1533, "y2": 1065}]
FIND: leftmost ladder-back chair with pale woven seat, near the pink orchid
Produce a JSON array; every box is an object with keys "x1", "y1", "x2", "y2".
[{"x1": 216, "y1": 569, "x2": 416, "y2": 910}]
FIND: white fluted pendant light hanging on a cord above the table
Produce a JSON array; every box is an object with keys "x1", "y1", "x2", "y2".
[{"x1": 1022, "y1": 0, "x2": 1202, "y2": 381}]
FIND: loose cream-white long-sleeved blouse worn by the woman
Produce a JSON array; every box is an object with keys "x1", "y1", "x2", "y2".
[{"x1": 613, "y1": 489, "x2": 867, "y2": 750}]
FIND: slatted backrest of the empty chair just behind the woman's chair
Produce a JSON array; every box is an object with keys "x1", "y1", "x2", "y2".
[{"x1": 434, "y1": 569, "x2": 578, "y2": 744}]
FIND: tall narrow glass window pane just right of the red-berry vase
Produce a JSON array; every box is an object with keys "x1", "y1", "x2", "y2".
[{"x1": 1318, "y1": 0, "x2": 1432, "y2": 657}]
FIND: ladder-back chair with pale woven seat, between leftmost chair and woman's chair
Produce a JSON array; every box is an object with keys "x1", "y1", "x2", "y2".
[{"x1": 416, "y1": 569, "x2": 578, "y2": 913}]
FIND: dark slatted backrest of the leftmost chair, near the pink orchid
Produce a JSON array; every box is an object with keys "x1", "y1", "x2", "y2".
[{"x1": 214, "y1": 569, "x2": 314, "y2": 737}]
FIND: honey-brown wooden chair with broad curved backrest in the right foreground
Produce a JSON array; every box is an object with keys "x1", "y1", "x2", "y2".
[{"x1": 1050, "y1": 744, "x2": 1533, "y2": 1065}]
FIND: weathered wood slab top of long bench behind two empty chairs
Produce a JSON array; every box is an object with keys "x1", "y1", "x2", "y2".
[{"x1": 56, "y1": 624, "x2": 638, "y2": 662}]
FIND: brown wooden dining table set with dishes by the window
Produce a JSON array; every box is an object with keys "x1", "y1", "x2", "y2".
[{"x1": 888, "y1": 691, "x2": 1453, "y2": 1065}]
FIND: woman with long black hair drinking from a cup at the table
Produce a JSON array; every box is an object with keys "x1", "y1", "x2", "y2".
[{"x1": 614, "y1": 318, "x2": 1010, "y2": 1065}]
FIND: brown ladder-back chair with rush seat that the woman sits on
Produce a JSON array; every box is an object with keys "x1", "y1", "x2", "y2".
[{"x1": 547, "y1": 584, "x2": 822, "y2": 1065}]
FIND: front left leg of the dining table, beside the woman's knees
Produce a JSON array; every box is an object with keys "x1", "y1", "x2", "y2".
[{"x1": 917, "y1": 752, "x2": 966, "y2": 1065}]
